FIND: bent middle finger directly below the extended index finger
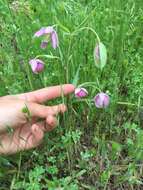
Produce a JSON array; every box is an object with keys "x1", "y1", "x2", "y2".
[{"x1": 27, "y1": 103, "x2": 67, "y2": 118}]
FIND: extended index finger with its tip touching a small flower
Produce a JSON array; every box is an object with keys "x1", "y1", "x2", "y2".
[{"x1": 17, "y1": 84, "x2": 75, "y2": 103}]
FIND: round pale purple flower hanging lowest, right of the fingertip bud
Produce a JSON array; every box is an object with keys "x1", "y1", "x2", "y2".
[{"x1": 94, "y1": 92, "x2": 110, "y2": 108}]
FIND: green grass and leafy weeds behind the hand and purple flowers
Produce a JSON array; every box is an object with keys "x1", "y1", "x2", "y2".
[{"x1": 0, "y1": 0, "x2": 143, "y2": 190}]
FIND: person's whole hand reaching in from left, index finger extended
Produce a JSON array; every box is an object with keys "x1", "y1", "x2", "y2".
[{"x1": 0, "y1": 84, "x2": 74, "y2": 154}]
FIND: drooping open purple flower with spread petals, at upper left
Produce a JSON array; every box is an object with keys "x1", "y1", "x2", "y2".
[{"x1": 34, "y1": 26, "x2": 59, "y2": 49}]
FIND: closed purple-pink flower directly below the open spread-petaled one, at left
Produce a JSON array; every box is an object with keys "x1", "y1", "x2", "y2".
[{"x1": 29, "y1": 59, "x2": 44, "y2": 74}]
